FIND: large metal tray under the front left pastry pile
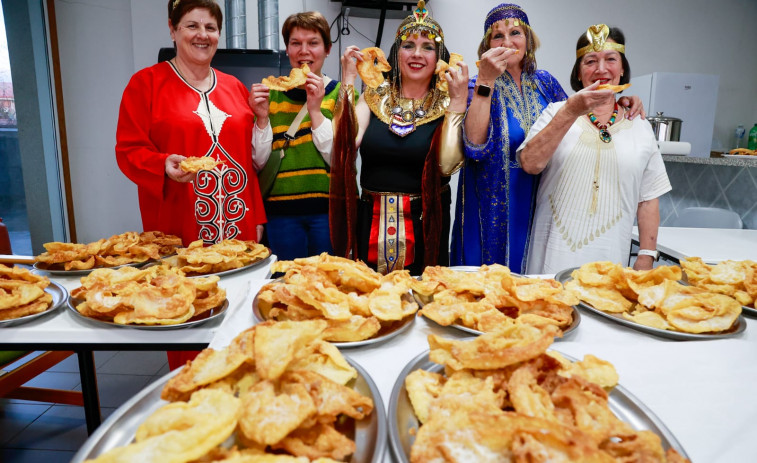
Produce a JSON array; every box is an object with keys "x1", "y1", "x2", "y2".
[{"x1": 71, "y1": 356, "x2": 387, "y2": 463}]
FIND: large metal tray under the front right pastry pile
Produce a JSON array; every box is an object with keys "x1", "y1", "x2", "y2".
[{"x1": 388, "y1": 351, "x2": 688, "y2": 463}]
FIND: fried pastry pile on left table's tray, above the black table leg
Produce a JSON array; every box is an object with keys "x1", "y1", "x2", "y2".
[{"x1": 71, "y1": 265, "x2": 226, "y2": 325}]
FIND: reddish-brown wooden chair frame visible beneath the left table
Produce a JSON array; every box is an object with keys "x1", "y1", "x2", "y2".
[{"x1": 0, "y1": 351, "x2": 84, "y2": 406}]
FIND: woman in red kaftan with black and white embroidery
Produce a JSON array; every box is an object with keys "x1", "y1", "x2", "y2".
[{"x1": 116, "y1": 0, "x2": 266, "y2": 369}]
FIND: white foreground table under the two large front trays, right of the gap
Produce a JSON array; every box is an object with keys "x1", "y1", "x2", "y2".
[{"x1": 210, "y1": 281, "x2": 757, "y2": 462}]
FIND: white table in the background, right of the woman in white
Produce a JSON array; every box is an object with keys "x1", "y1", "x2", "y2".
[{"x1": 631, "y1": 227, "x2": 757, "y2": 264}]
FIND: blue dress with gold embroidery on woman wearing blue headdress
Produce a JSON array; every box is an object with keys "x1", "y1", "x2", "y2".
[{"x1": 450, "y1": 70, "x2": 567, "y2": 273}]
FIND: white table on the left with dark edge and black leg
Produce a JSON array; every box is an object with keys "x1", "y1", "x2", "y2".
[{"x1": 0, "y1": 255, "x2": 276, "y2": 434}]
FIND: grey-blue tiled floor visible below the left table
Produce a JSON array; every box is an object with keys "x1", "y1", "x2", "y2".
[{"x1": 0, "y1": 352, "x2": 168, "y2": 463}]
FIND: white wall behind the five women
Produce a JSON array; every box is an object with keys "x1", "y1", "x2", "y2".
[{"x1": 55, "y1": 0, "x2": 757, "y2": 240}]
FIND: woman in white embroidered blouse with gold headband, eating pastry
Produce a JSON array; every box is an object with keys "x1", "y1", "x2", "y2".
[{"x1": 518, "y1": 24, "x2": 671, "y2": 273}]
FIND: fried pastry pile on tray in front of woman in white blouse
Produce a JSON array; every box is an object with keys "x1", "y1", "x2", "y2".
[{"x1": 565, "y1": 262, "x2": 741, "y2": 334}]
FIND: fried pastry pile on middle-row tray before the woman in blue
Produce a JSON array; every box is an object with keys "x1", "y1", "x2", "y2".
[{"x1": 413, "y1": 264, "x2": 578, "y2": 332}]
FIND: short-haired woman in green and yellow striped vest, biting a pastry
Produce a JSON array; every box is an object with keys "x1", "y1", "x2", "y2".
[{"x1": 250, "y1": 11, "x2": 339, "y2": 260}]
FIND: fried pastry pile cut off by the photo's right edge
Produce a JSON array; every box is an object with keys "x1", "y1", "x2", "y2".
[{"x1": 681, "y1": 257, "x2": 757, "y2": 308}]
